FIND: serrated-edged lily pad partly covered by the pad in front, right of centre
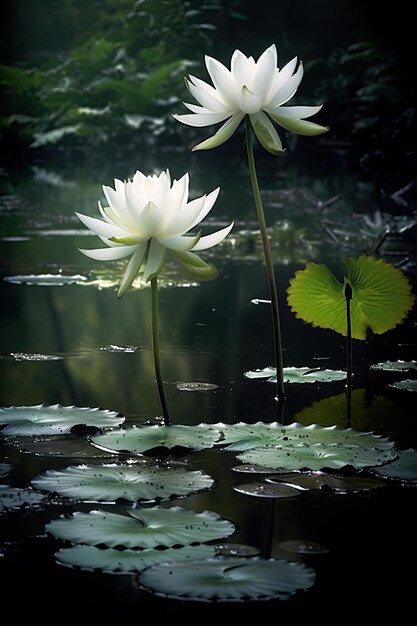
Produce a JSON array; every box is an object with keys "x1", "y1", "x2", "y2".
[{"x1": 214, "y1": 422, "x2": 394, "y2": 450}]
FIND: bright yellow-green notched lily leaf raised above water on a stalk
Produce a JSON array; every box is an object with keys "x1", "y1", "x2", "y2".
[{"x1": 287, "y1": 256, "x2": 415, "y2": 340}]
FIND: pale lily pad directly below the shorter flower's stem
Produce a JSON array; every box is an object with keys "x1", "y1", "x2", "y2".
[{"x1": 91, "y1": 424, "x2": 220, "y2": 454}]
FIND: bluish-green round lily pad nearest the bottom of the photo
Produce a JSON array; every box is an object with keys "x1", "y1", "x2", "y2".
[{"x1": 139, "y1": 557, "x2": 316, "y2": 602}]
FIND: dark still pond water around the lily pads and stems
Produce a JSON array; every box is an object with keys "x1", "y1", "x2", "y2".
[{"x1": 0, "y1": 147, "x2": 417, "y2": 623}]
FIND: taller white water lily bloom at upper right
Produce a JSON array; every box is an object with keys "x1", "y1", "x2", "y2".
[{"x1": 174, "y1": 45, "x2": 328, "y2": 154}]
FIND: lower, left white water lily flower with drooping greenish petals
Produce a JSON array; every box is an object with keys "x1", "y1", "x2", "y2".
[{"x1": 76, "y1": 170, "x2": 233, "y2": 298}]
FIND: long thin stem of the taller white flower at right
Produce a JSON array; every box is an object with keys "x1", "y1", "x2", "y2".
[{"x1": 246, "y1": 115, "x2": 285, "y2": 400}]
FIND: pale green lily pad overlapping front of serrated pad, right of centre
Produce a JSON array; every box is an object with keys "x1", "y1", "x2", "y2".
[{"x1": 237, "y1": 444, "x2": 396, "y2": 470}]
